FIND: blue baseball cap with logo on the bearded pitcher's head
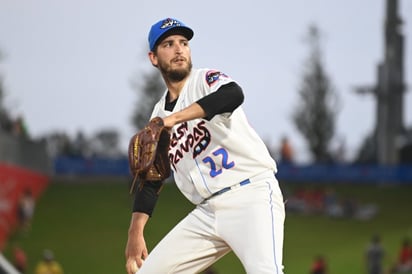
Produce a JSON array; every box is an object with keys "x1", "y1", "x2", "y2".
[{"x1": 149, "y1": 18, "x2": 194, "y2": 51}]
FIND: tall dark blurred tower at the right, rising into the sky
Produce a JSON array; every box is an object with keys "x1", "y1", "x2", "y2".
[{"x1": 357, "y1": 0, "x2": 412, "y2": 165}]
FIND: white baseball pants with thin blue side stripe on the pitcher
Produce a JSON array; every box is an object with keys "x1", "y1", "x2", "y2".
[{"x1": 138, "y1": 172, "x2": 285, "y2": 274}]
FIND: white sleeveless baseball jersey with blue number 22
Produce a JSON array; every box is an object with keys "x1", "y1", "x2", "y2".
[{"x1": 152, "y1": 69, "x2": 277, "y2": 204}]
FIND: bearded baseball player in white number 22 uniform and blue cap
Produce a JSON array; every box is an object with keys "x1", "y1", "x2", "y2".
[{"x1": 125, "y1": 18, "x2": 285, "y2": 274}]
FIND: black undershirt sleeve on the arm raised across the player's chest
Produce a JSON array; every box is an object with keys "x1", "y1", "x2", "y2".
[{"x1": 196, "y1": 82, "x2": 244, "y2": 120}]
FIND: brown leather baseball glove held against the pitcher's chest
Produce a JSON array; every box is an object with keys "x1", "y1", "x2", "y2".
[{"x1": 129, "y1": 117, "x2": 171, "y2": 193}]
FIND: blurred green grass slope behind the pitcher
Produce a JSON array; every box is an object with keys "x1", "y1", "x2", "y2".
[{"x1": 5, "y1": 179, "x2": 412, "y2": 274}]
